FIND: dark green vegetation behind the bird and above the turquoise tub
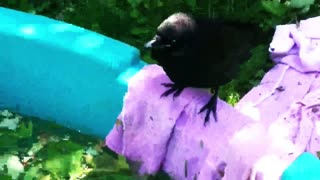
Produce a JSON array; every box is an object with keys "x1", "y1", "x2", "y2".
[{"x1": 0, "y1": 0, "x2": 320, "y2": 104}]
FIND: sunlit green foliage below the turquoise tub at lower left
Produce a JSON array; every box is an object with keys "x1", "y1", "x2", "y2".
[{"x1": 0, "y1": 110, "x2": 172, "y2": 180}]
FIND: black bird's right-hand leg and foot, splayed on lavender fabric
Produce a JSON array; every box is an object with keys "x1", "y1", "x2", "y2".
[{"x1": 199, "y1": 87, "x2": 219, "y2": 125}]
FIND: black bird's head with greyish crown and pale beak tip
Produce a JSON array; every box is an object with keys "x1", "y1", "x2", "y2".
[{"x1": 145, "y1": 13, "x2": 195, "y2": 60}]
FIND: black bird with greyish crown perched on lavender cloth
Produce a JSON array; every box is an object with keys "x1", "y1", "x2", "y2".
[{"x1": 145, "y1": 12, "x2": 270, "y2": 124}]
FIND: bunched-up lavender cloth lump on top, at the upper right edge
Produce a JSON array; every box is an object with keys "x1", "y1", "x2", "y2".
[{"x1": 269, "y1": 16, "x2": 320, "y2": 72}]
